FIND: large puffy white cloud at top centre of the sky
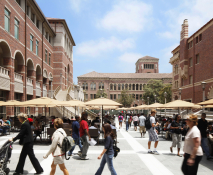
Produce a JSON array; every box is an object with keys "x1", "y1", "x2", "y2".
[{"x1": 98, "y1": 0, "x2": 152, "y2": 32}]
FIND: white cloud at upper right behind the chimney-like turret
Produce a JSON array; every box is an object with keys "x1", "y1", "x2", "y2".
[{"x1": 157, "y1": 0, "x2": 213, "y2": 39}]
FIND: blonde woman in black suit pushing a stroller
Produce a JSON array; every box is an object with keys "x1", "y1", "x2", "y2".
[{"x1": 9, "y1": 113, "x2": 43, "y2": 175}]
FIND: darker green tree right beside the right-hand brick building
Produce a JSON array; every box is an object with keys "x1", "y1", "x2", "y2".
[{"x1": 159, "y1": 84, "x2": 172, "y2": 104}]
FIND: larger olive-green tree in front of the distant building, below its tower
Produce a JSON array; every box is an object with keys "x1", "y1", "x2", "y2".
[{"x1": 143, "y1": 80, "x2": 164, "y2": 104}]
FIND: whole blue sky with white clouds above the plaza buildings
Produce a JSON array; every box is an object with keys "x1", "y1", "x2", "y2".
[{"x1": 36, "y1": 0, "x2": 213, "y2": 83}]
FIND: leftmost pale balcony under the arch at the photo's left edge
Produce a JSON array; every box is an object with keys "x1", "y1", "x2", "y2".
[{"x1": 0, "y1": 67, "x2": 10, "y2": 91}]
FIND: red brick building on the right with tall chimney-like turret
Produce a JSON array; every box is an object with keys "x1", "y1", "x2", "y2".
[{"x1": 170, "y1": 19, "x2": 213, "y2": 103}]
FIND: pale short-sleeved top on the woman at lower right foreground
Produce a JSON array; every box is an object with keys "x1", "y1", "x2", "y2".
[{"x1": 183, "y1": 126, "x2": 203, "y2": 156}]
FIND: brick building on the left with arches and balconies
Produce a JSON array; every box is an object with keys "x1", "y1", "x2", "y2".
[{"x1": 0, "y1": 0, "x2": 75, "y2": 116}]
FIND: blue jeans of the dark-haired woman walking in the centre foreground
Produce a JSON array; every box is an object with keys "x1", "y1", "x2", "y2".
[{"x1": 95, "y1": 154, "x2": 117, "y2": 175}]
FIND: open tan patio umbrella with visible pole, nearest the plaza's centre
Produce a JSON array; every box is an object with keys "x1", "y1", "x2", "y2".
[{"x1": 85, "y1": 97, "x2": 122, "y2": 125}]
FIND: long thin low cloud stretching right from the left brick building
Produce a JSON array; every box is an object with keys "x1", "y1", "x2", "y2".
[{"x1": 76, "y1": 37, "x2": 135, "y2": 57}]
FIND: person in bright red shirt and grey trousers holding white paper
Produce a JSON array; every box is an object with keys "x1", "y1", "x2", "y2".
[{"x1": 78, "y1": 112, "x2": 91, "y2": 160}]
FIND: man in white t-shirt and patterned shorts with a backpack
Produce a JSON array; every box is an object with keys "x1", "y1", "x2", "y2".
[{"x1": 148, "y1": 109, "x2": 159, "y2": 155}]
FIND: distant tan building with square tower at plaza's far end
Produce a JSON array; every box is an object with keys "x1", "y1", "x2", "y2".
[{"x1": 78, "y1": 56, "x2": 172, "y2": 106}]
